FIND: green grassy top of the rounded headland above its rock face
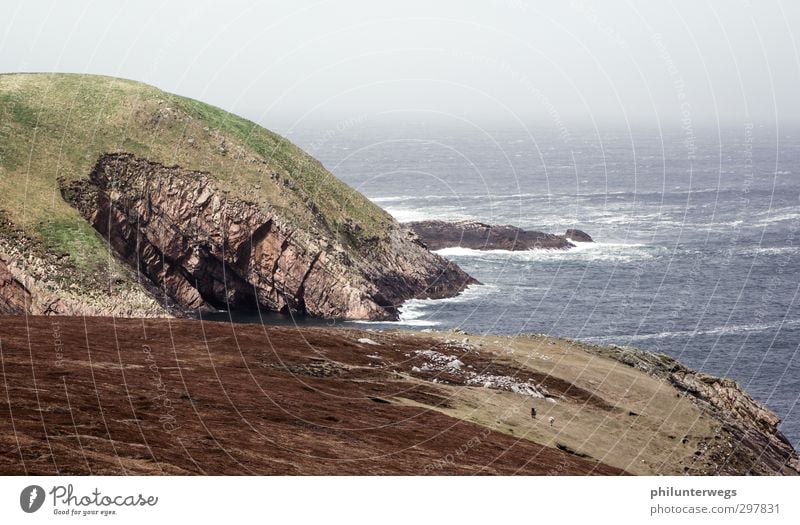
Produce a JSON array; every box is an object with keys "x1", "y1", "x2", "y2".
[{"x1": 0, "y1": 74, "x2": 393, "y2": 280}]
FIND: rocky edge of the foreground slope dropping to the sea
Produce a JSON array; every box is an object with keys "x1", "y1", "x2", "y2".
[{"x1": 589, "y1": 345, "x2": 800, "y2": 475}]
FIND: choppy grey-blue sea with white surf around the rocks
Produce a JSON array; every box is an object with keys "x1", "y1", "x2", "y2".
[{"x1": 252, "y1": 119, "x2": 800, "y2": 447}]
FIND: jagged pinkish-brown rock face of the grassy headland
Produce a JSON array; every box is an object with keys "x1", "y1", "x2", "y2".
[{"x1": 61, "y1": 154, "x2": 475, "y2": 320}]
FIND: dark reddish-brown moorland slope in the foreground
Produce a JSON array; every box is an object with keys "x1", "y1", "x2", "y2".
[{"x1": 0, "y1": 317, "x2": 621, "y2": 474}]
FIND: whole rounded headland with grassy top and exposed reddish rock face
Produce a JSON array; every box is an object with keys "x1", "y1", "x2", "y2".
[{"x1": 0, "y1": 74, "x2": 475, "y2": 319}]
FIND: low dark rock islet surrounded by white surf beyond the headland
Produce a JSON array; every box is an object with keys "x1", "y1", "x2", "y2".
[{"x1": 405, "y1": 221, "x2": 592, "y2": 251}]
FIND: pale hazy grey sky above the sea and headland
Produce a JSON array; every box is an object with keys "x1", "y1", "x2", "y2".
[{"x1": 0, "y1": 0, "x2": 800, "y2": 126}]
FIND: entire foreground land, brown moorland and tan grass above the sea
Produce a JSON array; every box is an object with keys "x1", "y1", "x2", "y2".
[{"x1": 0, "y1": 316, "x2": 798, "y2": 475}]
